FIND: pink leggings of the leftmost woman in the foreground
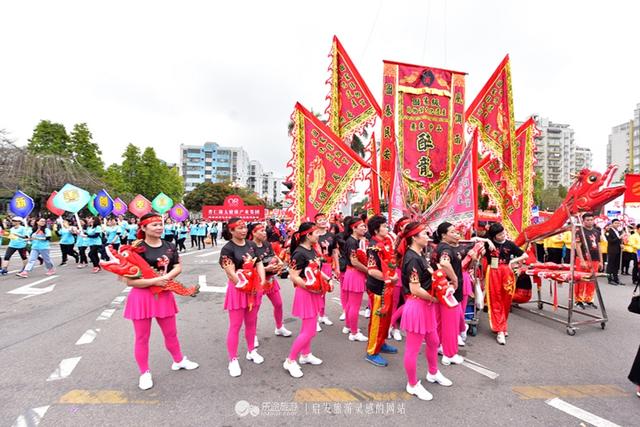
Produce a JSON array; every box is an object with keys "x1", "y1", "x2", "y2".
[{"x1": 133, "y1": 316, "x2": 182, "y2": 374}]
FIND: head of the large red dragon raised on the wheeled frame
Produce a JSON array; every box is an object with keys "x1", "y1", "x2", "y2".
[{"x1": 565, "y1": 165, "x2": 625, "y2": 215}]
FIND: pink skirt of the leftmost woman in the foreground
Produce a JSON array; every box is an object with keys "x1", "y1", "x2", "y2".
[{"x1": 124, "y1": 287, "x2": 178, "y2": 320}]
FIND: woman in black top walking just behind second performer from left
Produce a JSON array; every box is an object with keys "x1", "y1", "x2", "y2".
[{"x1": 249, "y1": 224, "x2": 291, "y2": 337}]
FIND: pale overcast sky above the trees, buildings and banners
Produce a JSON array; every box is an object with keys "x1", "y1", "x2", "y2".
[{"x1": 0, "y1": 0, "x2": 640, "y2": 175}]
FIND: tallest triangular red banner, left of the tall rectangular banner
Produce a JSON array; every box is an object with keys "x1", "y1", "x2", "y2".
[{"x1": 327, "y1": 36, "x2": 380, "y2": 141}]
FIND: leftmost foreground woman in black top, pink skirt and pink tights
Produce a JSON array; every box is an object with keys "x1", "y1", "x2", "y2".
[{"x1": 124, "y1": 213, "x2": 198, "y2": 390}]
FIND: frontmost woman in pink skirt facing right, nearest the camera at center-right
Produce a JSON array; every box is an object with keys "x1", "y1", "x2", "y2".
[{"x1": 398, "y1": 222, "x2": 455, "y2": 400}]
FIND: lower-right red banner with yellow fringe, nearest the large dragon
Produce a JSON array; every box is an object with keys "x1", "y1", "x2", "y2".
[{"x1": 478, "y1": 118, "x2": 538, "y2": 239}]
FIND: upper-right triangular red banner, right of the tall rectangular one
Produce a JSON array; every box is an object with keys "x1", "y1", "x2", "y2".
[{"x1": 466, "y1": 55, "x2": 518, "y2": 190}]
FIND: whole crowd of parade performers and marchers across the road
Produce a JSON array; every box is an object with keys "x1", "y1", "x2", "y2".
[{"x1": 0, "y1": 213, "x2": 640, "y2": 400}]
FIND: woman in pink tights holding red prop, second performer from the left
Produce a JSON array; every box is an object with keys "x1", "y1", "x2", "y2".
[{"x1": 220, "y1": 218, "x2": 265, "y2": 377}]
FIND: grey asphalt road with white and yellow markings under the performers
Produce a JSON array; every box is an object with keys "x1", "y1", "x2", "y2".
[{"x1": 0, "y1": 244, "x2": 640, "y2": 426}]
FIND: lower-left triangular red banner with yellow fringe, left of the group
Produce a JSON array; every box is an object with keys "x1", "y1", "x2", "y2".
[{"x1": 286, "y1": 103, "x2": 369, "y2": 224}]
